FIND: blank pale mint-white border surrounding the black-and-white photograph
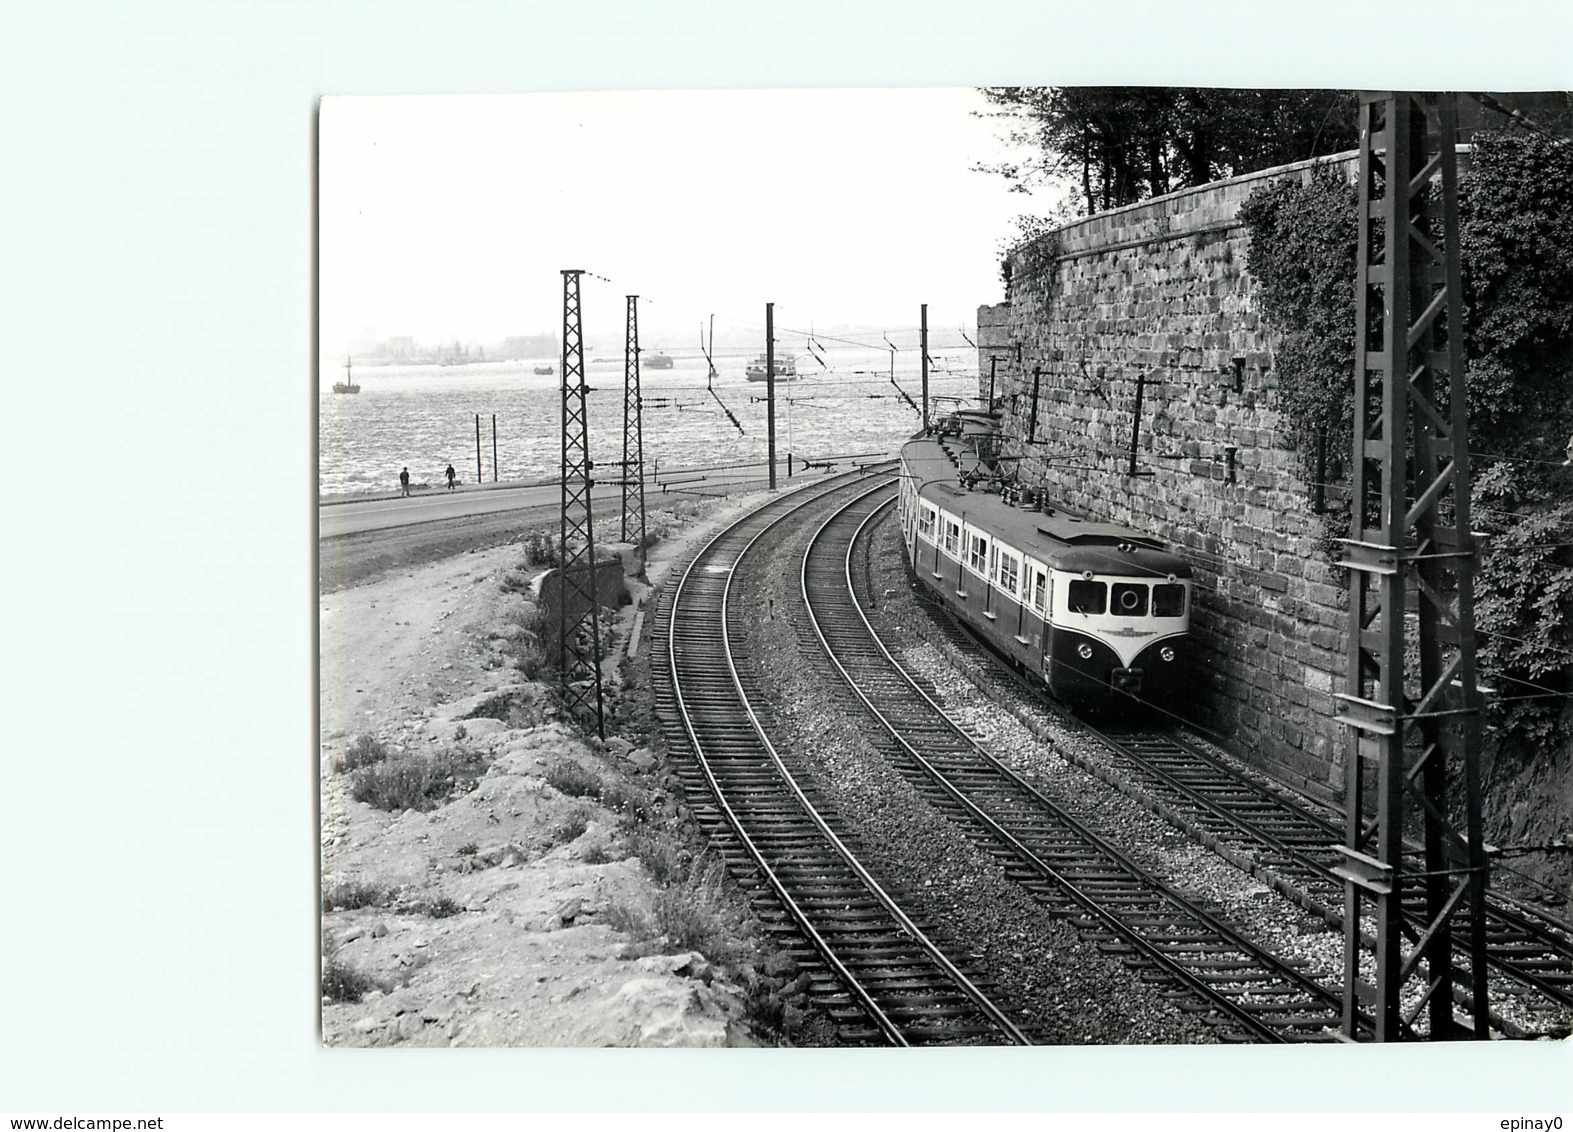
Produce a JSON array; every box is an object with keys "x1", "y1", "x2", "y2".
[{"x1": 0, "y1": 0, "x2": 1573, "y2": 1127}]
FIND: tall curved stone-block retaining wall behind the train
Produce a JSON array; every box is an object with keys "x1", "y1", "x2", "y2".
[{"x1": 978, "y1": 156, "x2": 1353, "y2": 796}]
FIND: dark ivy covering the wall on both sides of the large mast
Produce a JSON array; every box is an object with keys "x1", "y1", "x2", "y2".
[{"x1": 1241, "y1": 134, "x2": 1573, "y2": 750}]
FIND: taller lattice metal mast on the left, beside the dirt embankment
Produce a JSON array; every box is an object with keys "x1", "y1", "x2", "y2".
[{"x1": 557, "y1": 270, "x2": 606, "y2": 737}]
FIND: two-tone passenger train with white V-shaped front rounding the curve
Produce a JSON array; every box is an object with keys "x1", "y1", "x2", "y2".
[{"x1": 900, "y1": 410, "x2": 1192, "y2": 706}]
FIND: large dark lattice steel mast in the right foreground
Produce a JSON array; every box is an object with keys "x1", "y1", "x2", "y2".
[{"x1": 1335, "y1": 91, "x2": 1490, "y2": 1041}]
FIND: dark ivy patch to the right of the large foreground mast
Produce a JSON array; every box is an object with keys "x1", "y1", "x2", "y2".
[{"x1": 1458, "y1": 134, "x2": 1573, "y2": 752}]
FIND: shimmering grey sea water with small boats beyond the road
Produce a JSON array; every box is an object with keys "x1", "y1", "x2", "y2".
[{"x1": 318, "y1": 346, "x2": 978, "y2": 497}]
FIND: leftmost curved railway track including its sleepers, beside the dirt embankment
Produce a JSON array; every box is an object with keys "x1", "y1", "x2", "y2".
[{"x1": 658, "y1": 465, "x2": 1029, "y2": 1046}]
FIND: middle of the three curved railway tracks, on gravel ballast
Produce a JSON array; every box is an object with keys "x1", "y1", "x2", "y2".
[{"x1": 801, "y1": 487, "x2": 1342, "y2": 1041}]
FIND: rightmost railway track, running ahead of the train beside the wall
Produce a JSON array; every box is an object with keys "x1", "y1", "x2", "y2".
[{"x1": 862, "y1": 509, "x2": 1573, "y2": 1036}]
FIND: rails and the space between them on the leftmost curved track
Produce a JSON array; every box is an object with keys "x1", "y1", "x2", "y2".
[{"x1": 667, "y1": 465, "x2": 1029, "y2": 1046}]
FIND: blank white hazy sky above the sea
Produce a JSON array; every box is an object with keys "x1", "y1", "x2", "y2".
[{"x1": 319, "y1": 88, "x2": 1052, "y2": 357}]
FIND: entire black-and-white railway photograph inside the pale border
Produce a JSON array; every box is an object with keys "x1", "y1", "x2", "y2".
[{"x1": 316, "y1": 86, "x2": 1573, "y2": 1047}]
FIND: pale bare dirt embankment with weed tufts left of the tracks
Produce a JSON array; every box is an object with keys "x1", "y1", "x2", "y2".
[{"x1": 319, "y1": 505, "x2": 813, "y2": 1046}]
